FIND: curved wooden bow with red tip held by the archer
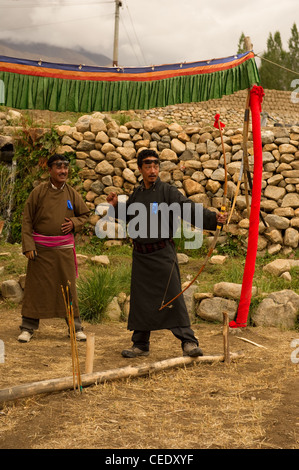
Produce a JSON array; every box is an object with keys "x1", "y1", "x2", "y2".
[{"x1": 159, "y1": 114, "x2": 227, "y2": 311}]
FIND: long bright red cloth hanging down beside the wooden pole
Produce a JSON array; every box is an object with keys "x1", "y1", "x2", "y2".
[{"x1": 229, "y1": 85, "x2": 265, "y2": 328}]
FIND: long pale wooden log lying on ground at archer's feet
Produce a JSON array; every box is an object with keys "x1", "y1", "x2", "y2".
[{"x1": 0, "y1": 353, "x2": 242, "y2": 403}]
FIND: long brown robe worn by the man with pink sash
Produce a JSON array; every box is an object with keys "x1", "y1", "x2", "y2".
[{"x1": 22, "y1": 182, "x2": 89, "y2": 319}]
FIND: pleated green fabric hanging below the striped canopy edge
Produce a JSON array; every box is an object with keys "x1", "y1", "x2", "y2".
[{"x1": 0, "y1": 59, "x2": 260, "y2": 113}]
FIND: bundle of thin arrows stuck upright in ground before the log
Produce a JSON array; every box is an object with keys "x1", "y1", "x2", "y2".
[{"x1": 61, "y1": 281, "x2": 83, "y2": 393}]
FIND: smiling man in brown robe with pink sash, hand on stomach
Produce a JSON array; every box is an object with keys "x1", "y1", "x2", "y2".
[{"x1": 18, "y1": 155, "x2": 89, "y2": 342}]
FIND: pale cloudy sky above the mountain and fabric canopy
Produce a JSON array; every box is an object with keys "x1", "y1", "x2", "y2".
[{"x1": 0, "y1": 0, "x2": 299, "y2": 67}]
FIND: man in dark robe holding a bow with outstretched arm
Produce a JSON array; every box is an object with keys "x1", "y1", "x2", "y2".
[{"x1": 107, "y1": 149, "x2": 227, "y2": 357}]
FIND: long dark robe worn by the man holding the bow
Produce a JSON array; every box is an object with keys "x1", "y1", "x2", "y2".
[{"x1": 109, "y1": 178, "x2": 216, "y2": 331}]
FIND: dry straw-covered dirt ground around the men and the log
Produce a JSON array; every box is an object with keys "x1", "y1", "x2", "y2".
[{"x1": 0, "y1": 301, "x2": 299, "y2": 449}]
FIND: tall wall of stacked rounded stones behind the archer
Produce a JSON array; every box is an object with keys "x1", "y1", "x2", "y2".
[{"x1": 57, "y1": 113, "x2": 299, "y2": 253}]
